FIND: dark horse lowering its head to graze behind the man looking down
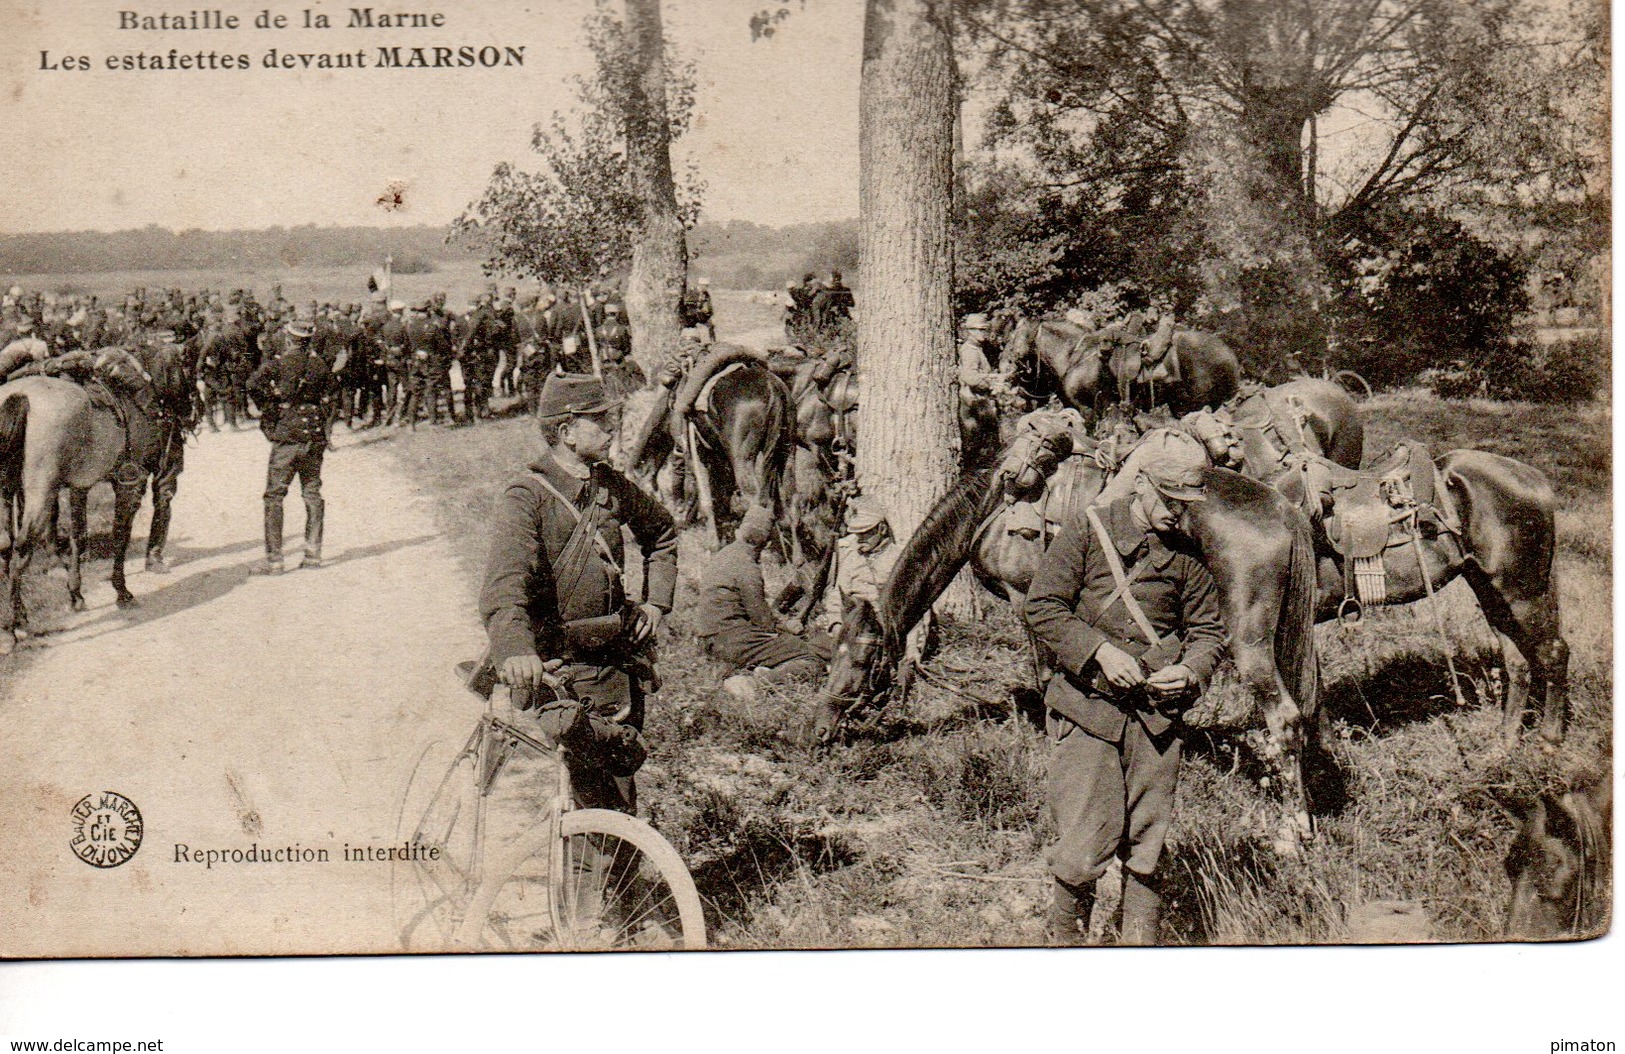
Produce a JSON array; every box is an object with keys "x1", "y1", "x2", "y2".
[{"x1": 816, "y1": 419, "x2": 1323, "y2": 851}]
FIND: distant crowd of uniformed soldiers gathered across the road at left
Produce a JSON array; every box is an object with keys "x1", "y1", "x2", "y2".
[{"x1": 0, "y1": 284, "x2": 646, "y2": 429}]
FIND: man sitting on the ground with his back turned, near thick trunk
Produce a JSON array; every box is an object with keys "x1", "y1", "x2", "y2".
[{"x1": 694, "y1": 505, "x2": 830, "y2": 698}]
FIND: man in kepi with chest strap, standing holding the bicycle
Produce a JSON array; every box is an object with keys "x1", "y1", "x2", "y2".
[{"x1": 479, "y1": 374, "x2": 678, "y2": 812}]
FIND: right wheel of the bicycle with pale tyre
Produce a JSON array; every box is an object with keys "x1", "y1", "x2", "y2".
[{"x1": 458, "y1": 809, "x2": 705, "y2": 952}]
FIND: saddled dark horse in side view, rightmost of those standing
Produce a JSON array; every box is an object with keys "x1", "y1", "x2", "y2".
[{"x1": 1180, "y1": 388, "x2": 1568, "y2": 744}]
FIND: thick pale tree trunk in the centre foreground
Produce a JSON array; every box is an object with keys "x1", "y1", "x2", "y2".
[{"x1": 856, "y1": 0, "x2": 959, "y2": 613}]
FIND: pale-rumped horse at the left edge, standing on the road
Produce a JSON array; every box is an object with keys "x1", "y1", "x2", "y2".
[{"x1": 0, "y1": 344, "x2": 198, "y2": 651}]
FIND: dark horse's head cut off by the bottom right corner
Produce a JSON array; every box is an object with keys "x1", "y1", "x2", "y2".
[{"x1": 1505, "y1": 778, "x2": 1614, "y2": 940}]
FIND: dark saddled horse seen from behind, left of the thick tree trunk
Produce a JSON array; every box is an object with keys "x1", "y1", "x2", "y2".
[{"x1": 627, "y1": 344, "x2": 791, "y2": 549}]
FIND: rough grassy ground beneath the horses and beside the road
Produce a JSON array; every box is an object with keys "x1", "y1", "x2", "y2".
[{"x1": 373, "y1": 289, "x2": 1612, "y2": 947}]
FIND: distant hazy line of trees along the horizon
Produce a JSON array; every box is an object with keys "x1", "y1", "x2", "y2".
[{"x1": 0, "y1": 219, "x2": 858, "y2": 289}]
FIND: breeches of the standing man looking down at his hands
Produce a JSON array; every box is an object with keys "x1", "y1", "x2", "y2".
[{"x1": 1050, "y1": 711, "x2": 1183, "y2": 885}]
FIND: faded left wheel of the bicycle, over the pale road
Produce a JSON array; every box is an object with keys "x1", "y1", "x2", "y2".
[{"x1": 390, "y1": 742, "x2": 478, "y2": 952}]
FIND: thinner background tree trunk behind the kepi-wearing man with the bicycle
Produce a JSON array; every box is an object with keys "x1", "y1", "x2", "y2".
[{"x1": 626, "y1": 0, "x2": 689, "y2": 377}]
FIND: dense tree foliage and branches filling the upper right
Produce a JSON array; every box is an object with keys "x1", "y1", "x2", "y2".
[{"x1": 960, "y1": 0, "x2": 1607, "y2": 388}]
